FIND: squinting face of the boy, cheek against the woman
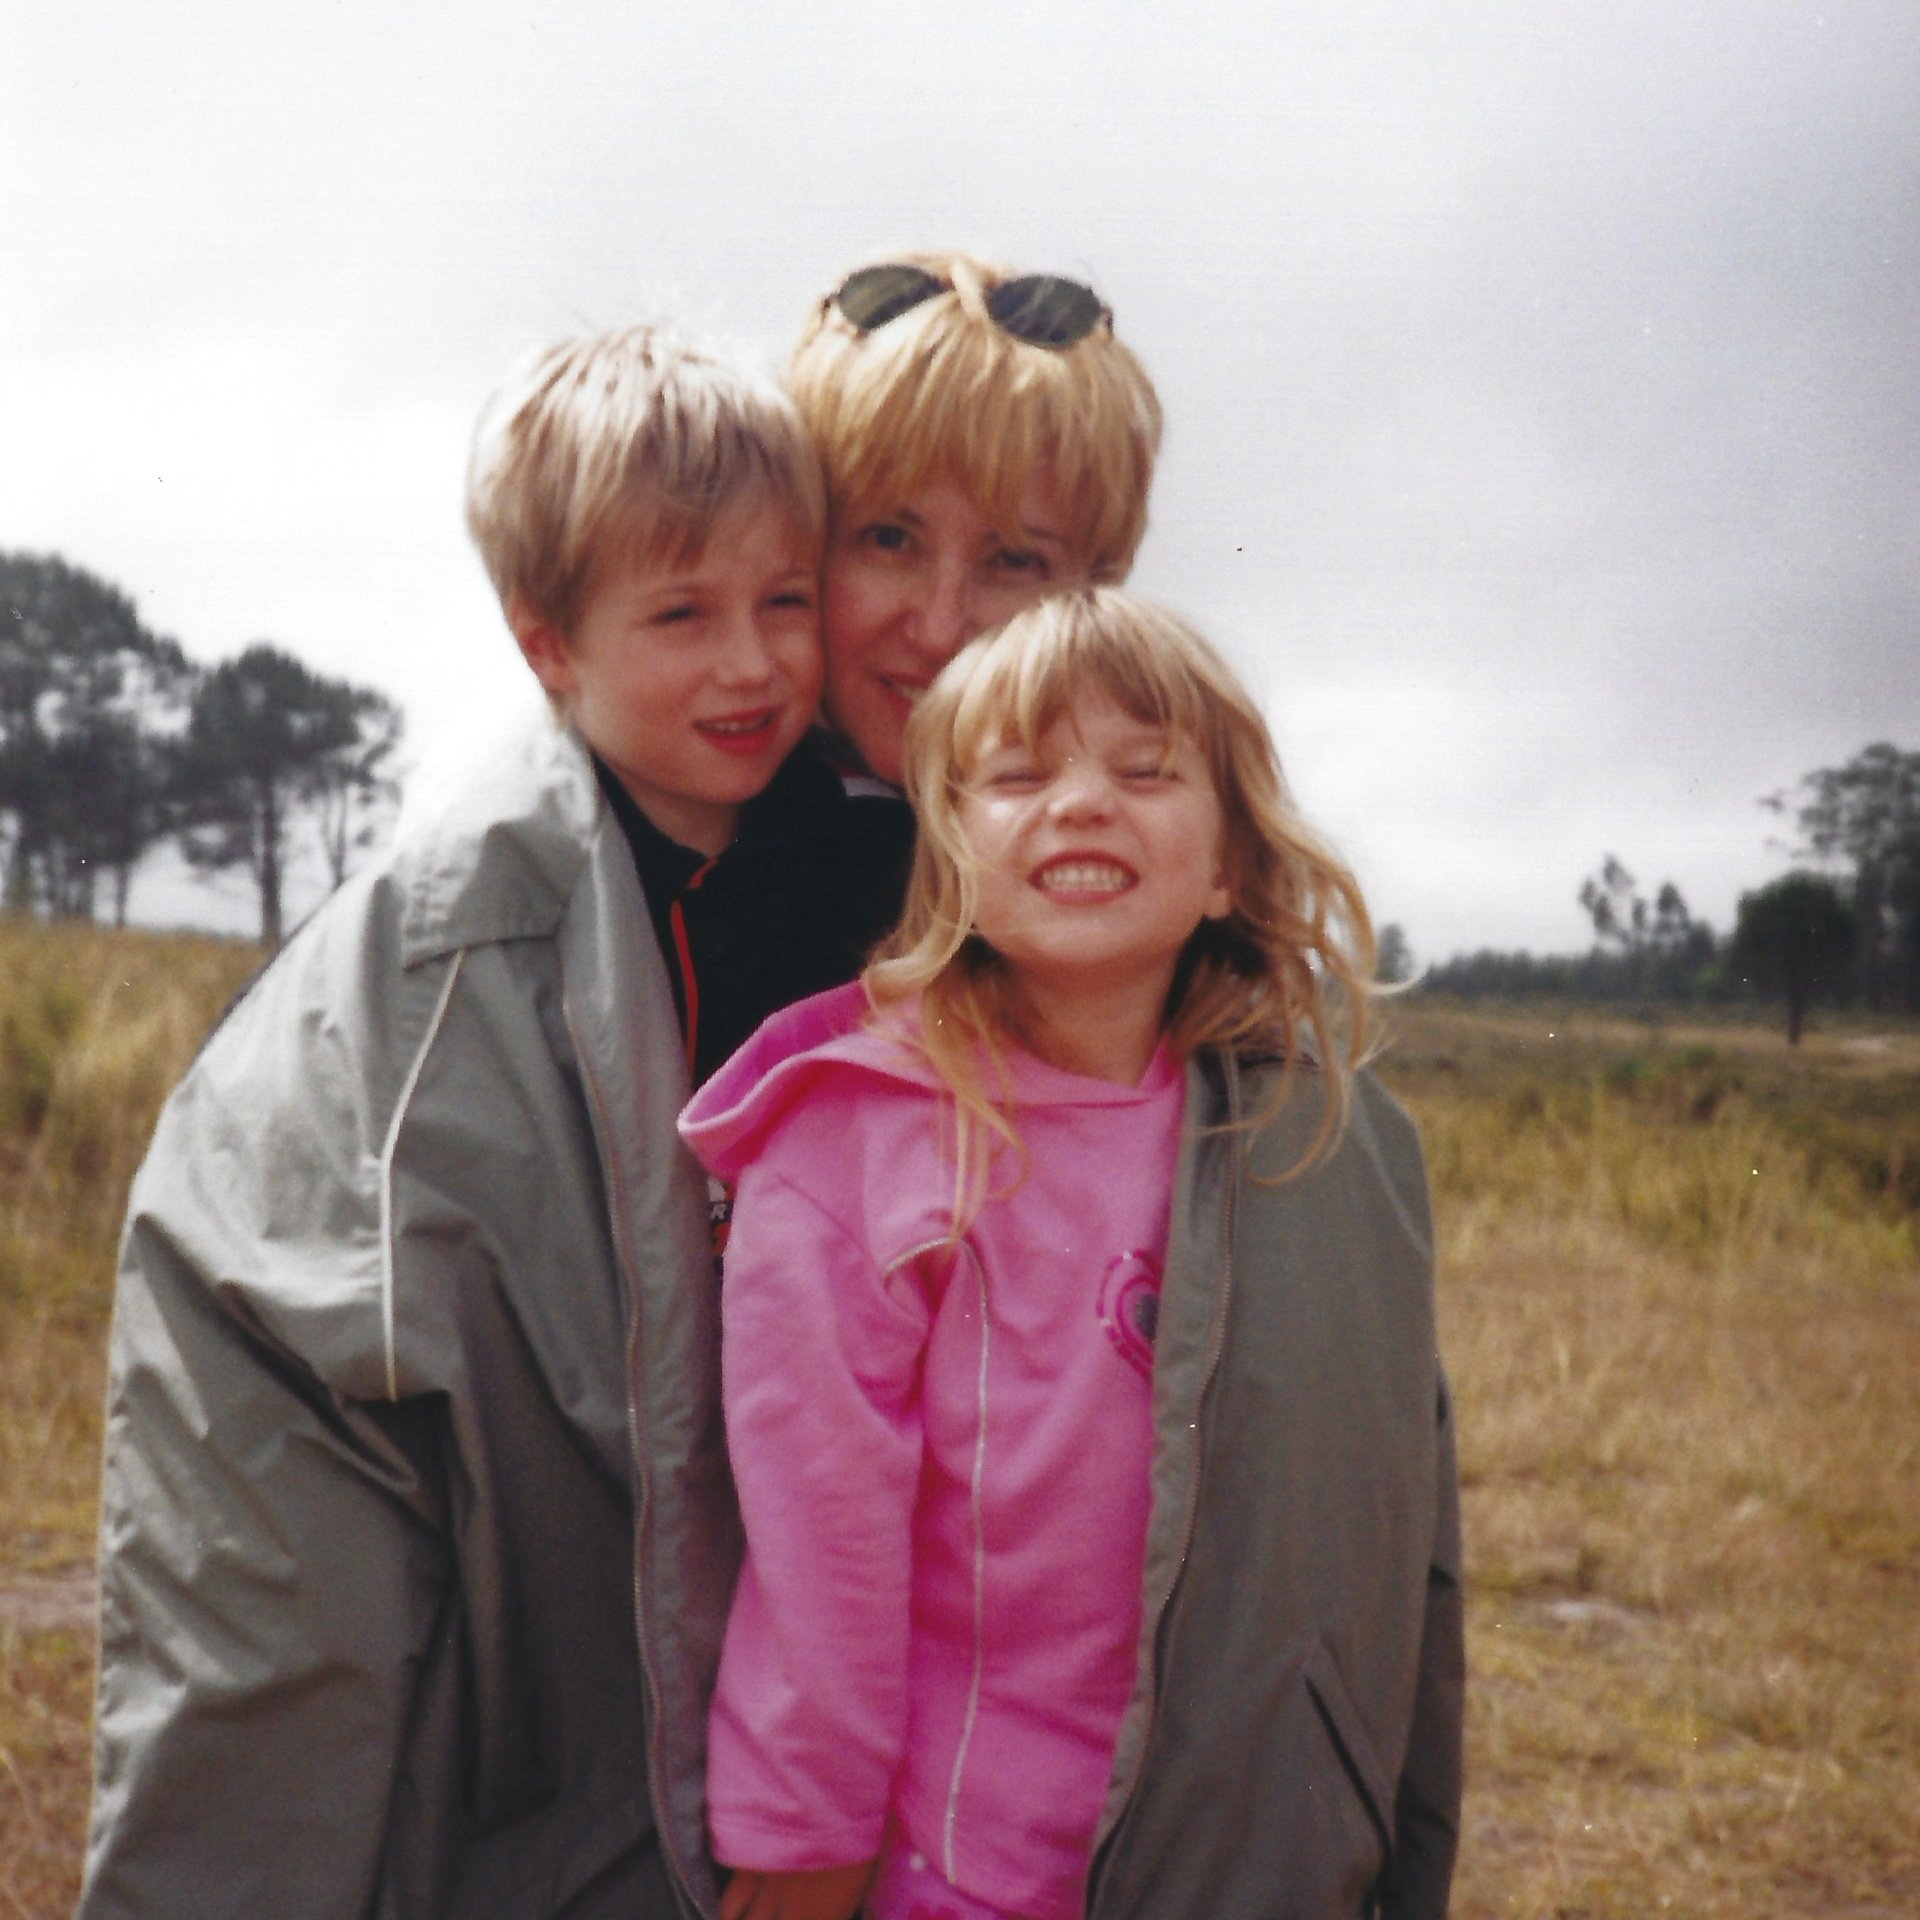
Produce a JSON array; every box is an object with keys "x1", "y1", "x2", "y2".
[{"x1": 513, "y1": 511, "x2": 822, "y2": 854}]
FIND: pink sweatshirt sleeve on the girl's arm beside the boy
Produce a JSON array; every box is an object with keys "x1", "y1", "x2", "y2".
[{"x1": 707, "y1": 1165, "x2": 929, "y2": 1872}]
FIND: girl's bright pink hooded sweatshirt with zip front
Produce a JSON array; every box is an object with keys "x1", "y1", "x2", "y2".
[{"x1": 680, "y1": 985, "x2": 1185, "y2": 1920}]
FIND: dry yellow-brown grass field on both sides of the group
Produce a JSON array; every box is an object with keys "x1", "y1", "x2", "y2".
[{"x1": 0, "y1": 924, "x2": 1920, "y2": 1920}]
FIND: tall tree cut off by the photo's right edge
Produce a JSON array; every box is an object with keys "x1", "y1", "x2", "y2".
[{"x1": 1764, "y1": 741, "x2": 1920, "y2": 1014}]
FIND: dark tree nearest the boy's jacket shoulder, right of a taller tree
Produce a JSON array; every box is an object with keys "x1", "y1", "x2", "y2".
[{"x1": 175, "y1": 641, "x2": 399, "y2": 947}]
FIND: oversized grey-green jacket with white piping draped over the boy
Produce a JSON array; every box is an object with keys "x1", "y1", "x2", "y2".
[{"x1": 81, "y1": 724, "x2": 739, "y2": 1920}]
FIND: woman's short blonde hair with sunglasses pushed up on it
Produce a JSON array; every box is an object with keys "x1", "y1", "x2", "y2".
[{"x1": 787, "y1": 253, "x2": 1160, "y2": 580}]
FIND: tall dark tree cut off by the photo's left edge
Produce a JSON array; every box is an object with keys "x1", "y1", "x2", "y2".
[{"x1": 0, "y1": 553, "x2": 192, "y2": 920}]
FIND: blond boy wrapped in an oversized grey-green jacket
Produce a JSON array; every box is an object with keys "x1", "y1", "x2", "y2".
[{"x1": 81, "y1": 328, "x2": 904, "y2": 1920}]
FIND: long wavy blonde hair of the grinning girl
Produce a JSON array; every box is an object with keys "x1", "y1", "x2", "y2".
[{"x1": 864, "y1": 588, "x2": 1375, "y2": 1231}]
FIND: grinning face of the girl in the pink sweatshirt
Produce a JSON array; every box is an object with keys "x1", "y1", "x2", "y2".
[{"x1": 960, "y1": 691, "x2": 1233, "y2": 1010}]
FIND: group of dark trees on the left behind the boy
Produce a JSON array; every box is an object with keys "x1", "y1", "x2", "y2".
[{"x1": 0, "y1": 551, "x2": 401, "y2": 945}]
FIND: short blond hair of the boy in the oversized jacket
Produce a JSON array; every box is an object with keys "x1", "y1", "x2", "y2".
[{"x1": 467, "y1": 326, "x2": 826, "y2": 636}]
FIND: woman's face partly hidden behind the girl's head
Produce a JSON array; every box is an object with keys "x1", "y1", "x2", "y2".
[{"x1": 822, "y1": 472, "x2": 1087, "y2": 783}]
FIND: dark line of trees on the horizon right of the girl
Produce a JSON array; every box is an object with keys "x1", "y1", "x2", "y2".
[{"x1": 1420, "y1": 741, "x2": 1920, "y2": 1041}]
